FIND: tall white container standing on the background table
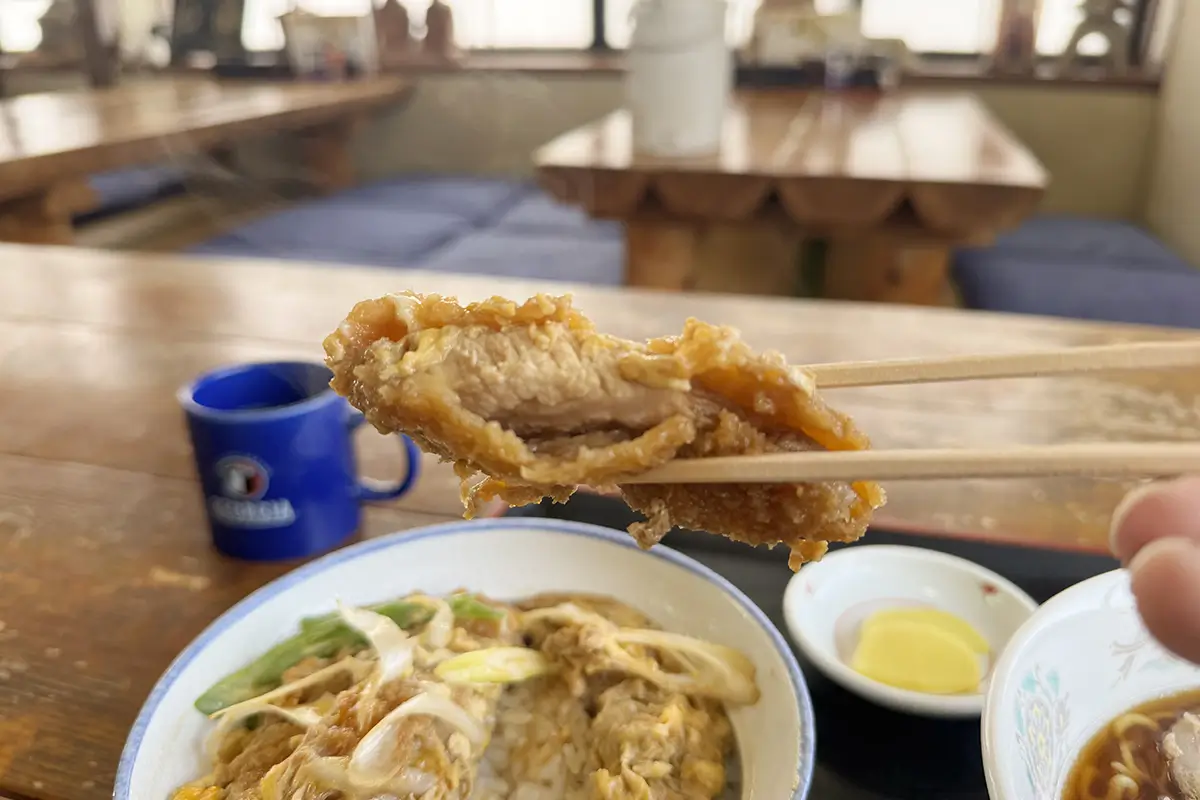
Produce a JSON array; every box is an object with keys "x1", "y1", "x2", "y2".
[{"x1": 625, "y1": 0, "x2": 733, "y2": 157}]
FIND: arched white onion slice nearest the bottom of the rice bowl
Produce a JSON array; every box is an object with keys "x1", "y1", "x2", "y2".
[{"x1": 348, "y1": 692, "x2": 487, "y2": 787}]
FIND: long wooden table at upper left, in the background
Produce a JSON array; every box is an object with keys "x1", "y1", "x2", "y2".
[{"x1": 0, "y1": 77, "x2": 410, "y2": 243}]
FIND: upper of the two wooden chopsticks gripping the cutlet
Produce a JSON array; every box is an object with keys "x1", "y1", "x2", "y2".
[{"x1": 806, "y1": 338, "x2": 1200, "y2": 389}]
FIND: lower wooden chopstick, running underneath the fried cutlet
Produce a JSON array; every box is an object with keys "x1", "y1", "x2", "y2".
[{"x1": 618, "y1": 441, "x2": 1200, "y2": 483}]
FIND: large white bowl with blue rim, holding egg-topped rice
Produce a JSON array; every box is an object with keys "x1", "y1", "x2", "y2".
[{"x1": 113, "y1": 518, "x2": 815, "y2": 800}]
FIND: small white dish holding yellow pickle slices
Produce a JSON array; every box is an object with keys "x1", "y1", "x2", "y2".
[{"x1": 784, "y1": 545, "x2": 1037, "y2": 717}]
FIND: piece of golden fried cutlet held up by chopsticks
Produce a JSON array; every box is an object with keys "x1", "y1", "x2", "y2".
[{"x1": 325, "y1": 291, "x2": 883, "y2": 570}]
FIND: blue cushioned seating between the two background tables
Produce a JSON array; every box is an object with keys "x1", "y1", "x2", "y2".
[{"x1": 191, "y1": 175, "x2": 624, "y2": 285}]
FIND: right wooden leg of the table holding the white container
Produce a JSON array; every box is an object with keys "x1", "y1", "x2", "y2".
[{"x1": 824, "y1": 234, "x2": 952, "y2": 306}]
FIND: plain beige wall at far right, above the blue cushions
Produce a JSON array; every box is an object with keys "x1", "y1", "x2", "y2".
[{"x1": 1146, "y1": 0, "x2": 1200, "y2": 265}]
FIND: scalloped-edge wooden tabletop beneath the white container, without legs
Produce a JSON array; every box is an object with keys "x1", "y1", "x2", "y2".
[{"x1": 534, "y1": 91, "x2": 1048, "y2": 227}]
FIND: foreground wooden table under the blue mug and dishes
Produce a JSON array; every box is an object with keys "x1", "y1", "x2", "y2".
[{"x1": 0, "y1": 245, "x2": 1200, "y2": 800}]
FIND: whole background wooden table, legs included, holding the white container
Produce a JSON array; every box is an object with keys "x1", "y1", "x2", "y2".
[{"x1": 534, "y1": 91, "x2": 1046, "y2": 305}]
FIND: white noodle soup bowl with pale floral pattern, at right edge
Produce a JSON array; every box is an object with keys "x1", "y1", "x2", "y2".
[{"x1": 982, "y1": 570, "x2": 1200, "y2": 800}]
